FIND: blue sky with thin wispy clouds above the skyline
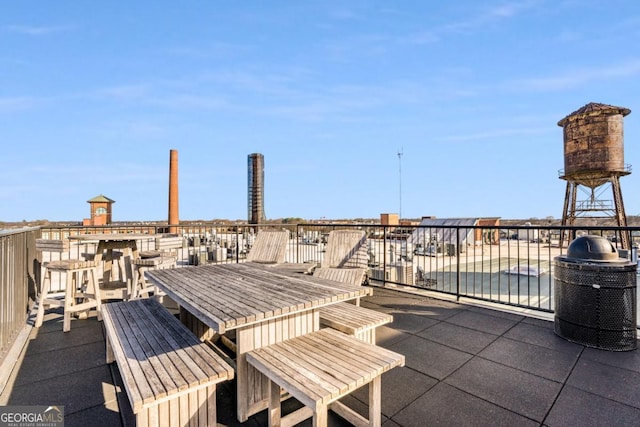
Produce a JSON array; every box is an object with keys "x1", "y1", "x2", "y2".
[{"x1": 0, "y1": 0, "x2": 640, "y2": 221}]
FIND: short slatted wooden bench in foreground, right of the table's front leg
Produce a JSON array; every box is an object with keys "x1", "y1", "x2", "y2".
[{"x1": 246, "y1": 329, "x2": 405, "y2": 426}]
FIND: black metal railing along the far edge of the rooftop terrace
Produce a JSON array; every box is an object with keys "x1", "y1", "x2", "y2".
[{"x1": 3, "y1": 223, "x2": 640, "y2": 338}]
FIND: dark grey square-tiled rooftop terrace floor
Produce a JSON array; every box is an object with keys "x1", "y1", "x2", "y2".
[{"x1": 0, "y1": 288, "x2": 640, "y2": 427}]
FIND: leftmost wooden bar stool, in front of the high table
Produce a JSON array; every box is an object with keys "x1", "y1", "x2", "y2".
[{"x1": 35, "y1": 239, "x2": 102, "y2": 332}]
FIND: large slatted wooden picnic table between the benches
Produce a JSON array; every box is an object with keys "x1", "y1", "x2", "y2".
[{"x1": 146, "y1": 263, "x2": 371, "y2": 422}]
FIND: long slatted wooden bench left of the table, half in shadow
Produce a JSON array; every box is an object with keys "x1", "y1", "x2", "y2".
[{"x1": 103, "y1": 299, "x2": 233, "y2": 426}]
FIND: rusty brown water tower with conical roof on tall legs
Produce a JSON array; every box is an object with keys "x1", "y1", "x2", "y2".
[{"x1": 558, "y1": 102, "x2": 631, "y2": 249}]
